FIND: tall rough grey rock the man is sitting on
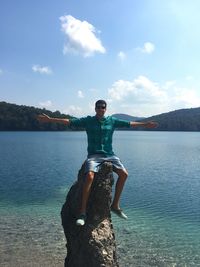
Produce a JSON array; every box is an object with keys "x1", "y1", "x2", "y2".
[{"x1": 61, "y1": 162, "x2": 119, "y2": 267}]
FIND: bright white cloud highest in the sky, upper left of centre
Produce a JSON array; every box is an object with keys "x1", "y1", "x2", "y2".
[{"x1": 60, "y1": 15, "x2": 106, "y2": 57}]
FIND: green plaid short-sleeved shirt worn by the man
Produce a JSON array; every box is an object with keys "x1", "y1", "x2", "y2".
[{"x1": 70, "y1": 116, "x2": 130, "y2": 156}]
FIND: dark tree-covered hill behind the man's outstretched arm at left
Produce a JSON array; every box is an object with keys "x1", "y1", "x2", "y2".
[{"x1": 0, "y1": 102, "x2": 74, "y2": 131}]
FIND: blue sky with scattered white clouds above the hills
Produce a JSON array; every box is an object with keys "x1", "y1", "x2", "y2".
[{"x1": 0, "y1": 0, "x2": 200, "y2": 117}]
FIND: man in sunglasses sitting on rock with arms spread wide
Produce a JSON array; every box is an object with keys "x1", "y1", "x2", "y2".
[{"x1": 38, "y1": 100, "x2": 157, "y2": 226}]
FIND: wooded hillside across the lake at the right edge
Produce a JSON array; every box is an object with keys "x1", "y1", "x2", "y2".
[{"x1": 145, "y1": 108, "x2": 200, "y2": 131}]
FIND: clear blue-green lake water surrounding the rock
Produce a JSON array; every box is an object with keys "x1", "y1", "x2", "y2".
[{"x1": 0, "y1": 131, "x2": 200, "y2": 267}]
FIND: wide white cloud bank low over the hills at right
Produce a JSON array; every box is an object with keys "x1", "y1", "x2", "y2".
[{"x1": 108, "y1": 76, "x2": 200, "y2": 116}]
